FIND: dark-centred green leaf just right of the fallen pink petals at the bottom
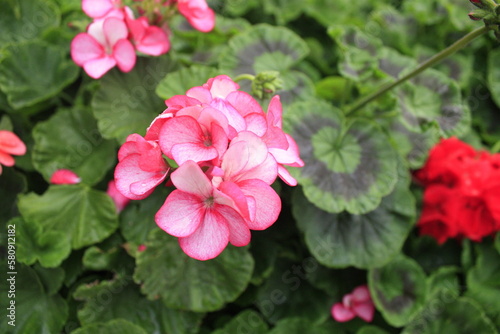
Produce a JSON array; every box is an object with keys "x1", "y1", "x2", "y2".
[{"x1": 368, "y1": 255, "x2": 427, "y2": 327}]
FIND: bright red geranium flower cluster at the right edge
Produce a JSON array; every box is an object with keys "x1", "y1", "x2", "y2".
[{"x1": 415, "y1": 138, "x2": 500, "y2": 244}]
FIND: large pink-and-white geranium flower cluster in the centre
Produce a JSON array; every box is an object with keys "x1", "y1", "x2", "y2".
[{"x1": 115, "y1": 75, "x2": 304, "y2": 260}]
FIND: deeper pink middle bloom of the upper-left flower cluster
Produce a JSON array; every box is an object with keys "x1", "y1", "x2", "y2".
[{"x1": 126, "y1": 16, "x2": 170, "y2": 56}]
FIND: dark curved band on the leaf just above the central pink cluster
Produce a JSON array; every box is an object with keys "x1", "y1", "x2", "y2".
[{"x1": 235, "y1": 39, "x2": 298, "y2": 74}]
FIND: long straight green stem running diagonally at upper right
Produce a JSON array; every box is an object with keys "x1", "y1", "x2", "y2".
[{"x1": 346, "y1": 26, "x2": 491, "y2": 115}]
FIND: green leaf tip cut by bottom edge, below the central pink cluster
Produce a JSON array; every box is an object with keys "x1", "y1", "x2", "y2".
[{"x1": 212, "y1": 310, "x2": 269, "y2": 334}]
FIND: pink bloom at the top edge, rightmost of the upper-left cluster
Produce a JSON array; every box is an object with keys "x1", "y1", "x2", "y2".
[{"x1": 178, "y1": 0, "x2": 215, "y2": 32}]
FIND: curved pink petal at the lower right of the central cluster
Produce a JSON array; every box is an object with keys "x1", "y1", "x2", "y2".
[{"x1": 237, "y1": 180, "x2": 281, "y2": 230}]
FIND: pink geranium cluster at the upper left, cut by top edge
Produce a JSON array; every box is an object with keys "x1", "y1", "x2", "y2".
[{"x1": 71, "y1": 0, "x2": 215, "y2": 79}]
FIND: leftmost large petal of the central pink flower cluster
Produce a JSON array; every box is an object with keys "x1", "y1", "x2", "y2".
[{"x1": 115, "y1": 154, "x2": 167, "y2": 200}]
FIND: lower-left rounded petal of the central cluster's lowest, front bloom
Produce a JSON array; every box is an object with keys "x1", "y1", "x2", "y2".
[{"x1": 155, "y1": 190, "x2": 205, "y2": 237}]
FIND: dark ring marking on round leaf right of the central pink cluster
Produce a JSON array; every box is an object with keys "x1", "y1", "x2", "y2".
[{"x1": 293, "y1": 116, "x2": 380, "y2": 200}]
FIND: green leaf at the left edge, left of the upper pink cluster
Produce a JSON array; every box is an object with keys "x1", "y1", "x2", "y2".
[{"x1": 0, "y1": 41, "x2": 79, "y2": 109}]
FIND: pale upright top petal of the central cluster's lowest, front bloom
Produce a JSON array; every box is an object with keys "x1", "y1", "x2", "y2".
[{"x1": 170, "y1": 160, "x2": 213, "y2": 199}]
